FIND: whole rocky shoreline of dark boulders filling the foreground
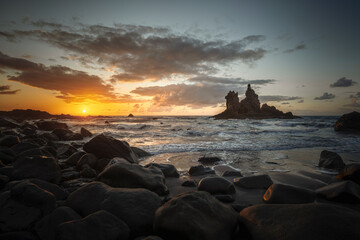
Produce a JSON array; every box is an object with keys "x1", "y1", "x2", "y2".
[{"x1": 0, "y1": 116, "x2": 360, "y2": 240}]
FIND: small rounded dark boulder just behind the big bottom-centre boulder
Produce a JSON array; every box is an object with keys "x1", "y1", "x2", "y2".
[{"x1": 198, "y1": 177, "x2": 235, "y2": 194}]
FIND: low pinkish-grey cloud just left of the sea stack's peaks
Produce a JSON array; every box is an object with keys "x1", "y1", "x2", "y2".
[{"x1": 131, "y1": 83, "x2": 244, "y2": 109}]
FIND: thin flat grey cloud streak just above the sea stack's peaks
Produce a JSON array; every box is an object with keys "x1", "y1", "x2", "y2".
[{"x1": 187, "y1": 75, "x2": 276, "y2": 85}]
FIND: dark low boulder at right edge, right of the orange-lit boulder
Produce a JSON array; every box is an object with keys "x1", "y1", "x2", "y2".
[{"x1": 316, "y1": 181, "x2": 360, "y2": 203}]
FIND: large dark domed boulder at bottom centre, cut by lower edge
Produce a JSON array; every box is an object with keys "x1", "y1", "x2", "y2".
[{"x1": 154, "y1": 192, "x2": 237, "y2": 240}]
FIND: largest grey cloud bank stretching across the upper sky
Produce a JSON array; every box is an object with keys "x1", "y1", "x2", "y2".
[{"x1": 5, "y1": 20, "x2": 267, "y2": 82}]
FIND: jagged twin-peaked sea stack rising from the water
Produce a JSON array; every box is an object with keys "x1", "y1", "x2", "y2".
[{"x1": 214, "y1": 84, "x2": 298, "y2": 119}]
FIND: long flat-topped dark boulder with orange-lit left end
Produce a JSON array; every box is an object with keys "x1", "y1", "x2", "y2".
[{"x1": 263, "y1": 184, "x2": 315, "y2": 204}]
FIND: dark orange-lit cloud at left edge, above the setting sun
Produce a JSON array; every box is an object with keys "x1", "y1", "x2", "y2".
[{"x1": 0, "y1": 52, "x2": 116, "y2": 101}]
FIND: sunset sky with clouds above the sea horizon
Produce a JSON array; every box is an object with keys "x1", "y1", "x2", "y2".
[{"x1": 0, "y1": 0, "x2": 360, "y2": 116}]
